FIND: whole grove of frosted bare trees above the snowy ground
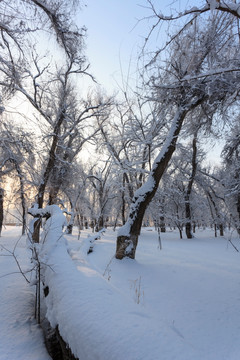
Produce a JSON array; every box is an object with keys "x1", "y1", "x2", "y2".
[{"x1": 0, "y1": 0, "x2": 240, "y2": 259}]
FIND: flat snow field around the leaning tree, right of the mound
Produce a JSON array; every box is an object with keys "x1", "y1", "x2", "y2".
[{"x1": 64, "y1": 230, "x2": 240, "y2": 360}]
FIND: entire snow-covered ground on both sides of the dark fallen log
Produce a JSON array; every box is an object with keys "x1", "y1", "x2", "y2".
[{"x1": 0, "y1": 228, "x2": 240, "y2": 360}]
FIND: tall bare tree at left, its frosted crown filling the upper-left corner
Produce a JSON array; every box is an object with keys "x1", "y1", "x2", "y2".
[{"x1": 0, "y1": 0, "x2": 88, "y2": 241}]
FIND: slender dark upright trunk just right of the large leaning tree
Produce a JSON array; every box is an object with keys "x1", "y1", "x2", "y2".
[{"x1": 185, "y1": 133, "x2": 197, "y2": 239}]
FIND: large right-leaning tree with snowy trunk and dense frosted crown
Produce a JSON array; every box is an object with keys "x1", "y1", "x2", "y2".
[{"x1": 116, "y1": 12, "x2": 240, "y2": 259}]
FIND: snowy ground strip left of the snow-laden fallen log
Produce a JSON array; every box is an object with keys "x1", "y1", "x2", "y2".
[{"x1": 0, "y1": 228, "x2": 50, "y2": 360}]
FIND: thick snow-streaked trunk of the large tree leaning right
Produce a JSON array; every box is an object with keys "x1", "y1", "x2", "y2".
[{"x1": 115, "y1": 107, "x2": 190, "y2": 259}]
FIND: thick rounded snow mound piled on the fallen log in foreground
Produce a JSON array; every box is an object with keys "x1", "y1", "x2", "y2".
[{"x1": 45, "y1": 239, "x2": 199, "y2": 360}]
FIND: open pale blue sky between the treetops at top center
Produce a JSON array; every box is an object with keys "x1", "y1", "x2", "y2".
[{"x1": 78, "y1": 0, "x2": 192, "y2": 91}]
